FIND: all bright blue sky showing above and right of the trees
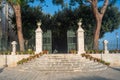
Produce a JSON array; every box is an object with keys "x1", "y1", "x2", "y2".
[{"x1": 31, "y1": 0, "x2": 120, "y2": 49}]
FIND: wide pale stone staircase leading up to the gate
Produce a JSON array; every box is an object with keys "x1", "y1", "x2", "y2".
[{"x1": 18, "y1": 54, "x2": 107, "y2": 72}]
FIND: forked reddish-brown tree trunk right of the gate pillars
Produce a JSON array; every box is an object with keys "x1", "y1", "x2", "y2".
[{"x1": 88, "y1": 0, "x2": 109, "y2": 50}]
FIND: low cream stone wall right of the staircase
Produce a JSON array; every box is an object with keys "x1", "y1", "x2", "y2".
[{"x1": 90, "y1": 54, "x2": 120, "y2": 66}]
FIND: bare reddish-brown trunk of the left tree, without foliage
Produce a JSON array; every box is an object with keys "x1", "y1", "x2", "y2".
[{"x1": 13, "y1": 4, "x2": 24, "y2": 51}]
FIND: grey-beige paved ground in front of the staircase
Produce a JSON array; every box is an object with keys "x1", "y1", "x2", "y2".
[{"x1": 0, "y1": 67, "x2": 120, "y2": 80}]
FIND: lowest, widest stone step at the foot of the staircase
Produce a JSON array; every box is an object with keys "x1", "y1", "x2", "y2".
[{"x1": 18, "y1": 66, "x2": 107, "y2": 72}]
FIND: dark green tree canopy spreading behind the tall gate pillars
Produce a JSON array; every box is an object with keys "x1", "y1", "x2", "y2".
[{"x1": 10, "y1": 0, "x2": 120, "y2": 49}]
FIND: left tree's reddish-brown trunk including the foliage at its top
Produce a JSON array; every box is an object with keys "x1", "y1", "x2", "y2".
[{"x1": 7, "y1": 0, "x2": 24, "y2": 51}]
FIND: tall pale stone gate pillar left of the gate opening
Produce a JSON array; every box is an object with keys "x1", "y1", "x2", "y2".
[{"x1": 35, "y1": 22, "x2": 42, "y2": 54}]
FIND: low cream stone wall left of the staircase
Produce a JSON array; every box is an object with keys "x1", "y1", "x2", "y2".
[{"x1": 0, "y1": 55, "x2": 30, "y2": 67}]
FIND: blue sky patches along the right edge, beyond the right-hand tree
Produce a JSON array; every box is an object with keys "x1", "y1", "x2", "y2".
[{"x1": 99, "y1": 0, "x2": 120, "y2": 50}]
